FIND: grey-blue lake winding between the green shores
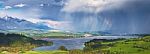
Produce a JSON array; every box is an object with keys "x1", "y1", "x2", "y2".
[{"x1": 33, "y1": 36, "x2": 139, "y2": 51}]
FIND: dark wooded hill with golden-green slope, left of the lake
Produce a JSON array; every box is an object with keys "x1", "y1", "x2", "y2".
[{"x1": 0, "y1": 33, "x2": 52, "y2": 52}]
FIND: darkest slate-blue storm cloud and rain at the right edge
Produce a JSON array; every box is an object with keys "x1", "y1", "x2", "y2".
[{"x1": 101, "y1": 0, "x2": 150, "y2": 33}]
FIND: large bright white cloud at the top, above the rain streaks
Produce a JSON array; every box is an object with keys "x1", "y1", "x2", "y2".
[{"x1": 62, "y1": 0, "x2": 125, "y2": 12}]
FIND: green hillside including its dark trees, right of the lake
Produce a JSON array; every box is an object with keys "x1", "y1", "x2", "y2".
[{"x1": 85, "y1": 36, "x2": 150, "y2": 54}]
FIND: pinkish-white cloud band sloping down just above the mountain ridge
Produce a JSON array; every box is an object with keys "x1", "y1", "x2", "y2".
[{"x1": 26, "y1": 18, "x2": 69, "y2": 30}]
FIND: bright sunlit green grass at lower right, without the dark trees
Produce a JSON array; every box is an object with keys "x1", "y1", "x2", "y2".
[{"x1": 104, "y1": 37, "x2": 150, "y2": 54}]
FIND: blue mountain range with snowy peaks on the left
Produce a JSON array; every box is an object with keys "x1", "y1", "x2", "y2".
[{"x1": 0, "y1": 16, "x2": 52, "y2": 30}]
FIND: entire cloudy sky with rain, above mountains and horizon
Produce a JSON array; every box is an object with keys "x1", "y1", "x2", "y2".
[{"x1": 0, "y1": 0, "x2": 150, "y2": 34}]
